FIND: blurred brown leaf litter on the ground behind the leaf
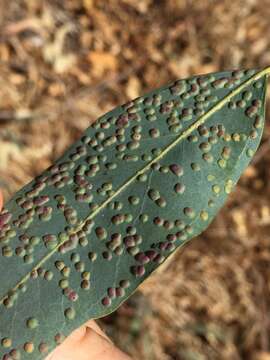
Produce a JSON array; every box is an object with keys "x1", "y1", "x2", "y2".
[{"x1": 0, "y1": 0, "x2": 270, "y2": 360}]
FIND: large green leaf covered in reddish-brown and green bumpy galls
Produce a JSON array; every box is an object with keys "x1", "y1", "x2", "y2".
[{"x1": 0, "y1": 69, "x2": 269, "y2": 360}]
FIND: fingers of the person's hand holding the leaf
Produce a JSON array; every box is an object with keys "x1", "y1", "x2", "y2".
[{"x1": 0, "y1": 192, "x2": 131, "y2": 360}]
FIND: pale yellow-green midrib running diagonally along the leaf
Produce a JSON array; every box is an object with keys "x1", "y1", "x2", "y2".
[{"x1": 0, "y1": 66, "x2": 270, "y2": 304}]
